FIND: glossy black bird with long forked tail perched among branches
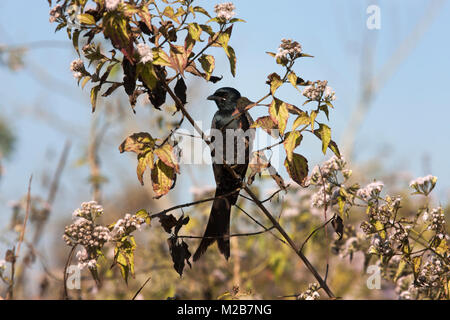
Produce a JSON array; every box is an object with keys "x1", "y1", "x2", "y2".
[{"x1": 194, "y1": 87, "x2": 253, "y2": 261}]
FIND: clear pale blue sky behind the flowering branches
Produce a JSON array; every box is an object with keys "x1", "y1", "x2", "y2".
[{"x1": 0, "y1": 0, "x2": 450, "y2": 228}]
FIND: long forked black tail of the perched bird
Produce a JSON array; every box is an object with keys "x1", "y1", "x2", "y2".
[{"x1": 194, "y1": 188, "x2": 238, "y2": 261}]
